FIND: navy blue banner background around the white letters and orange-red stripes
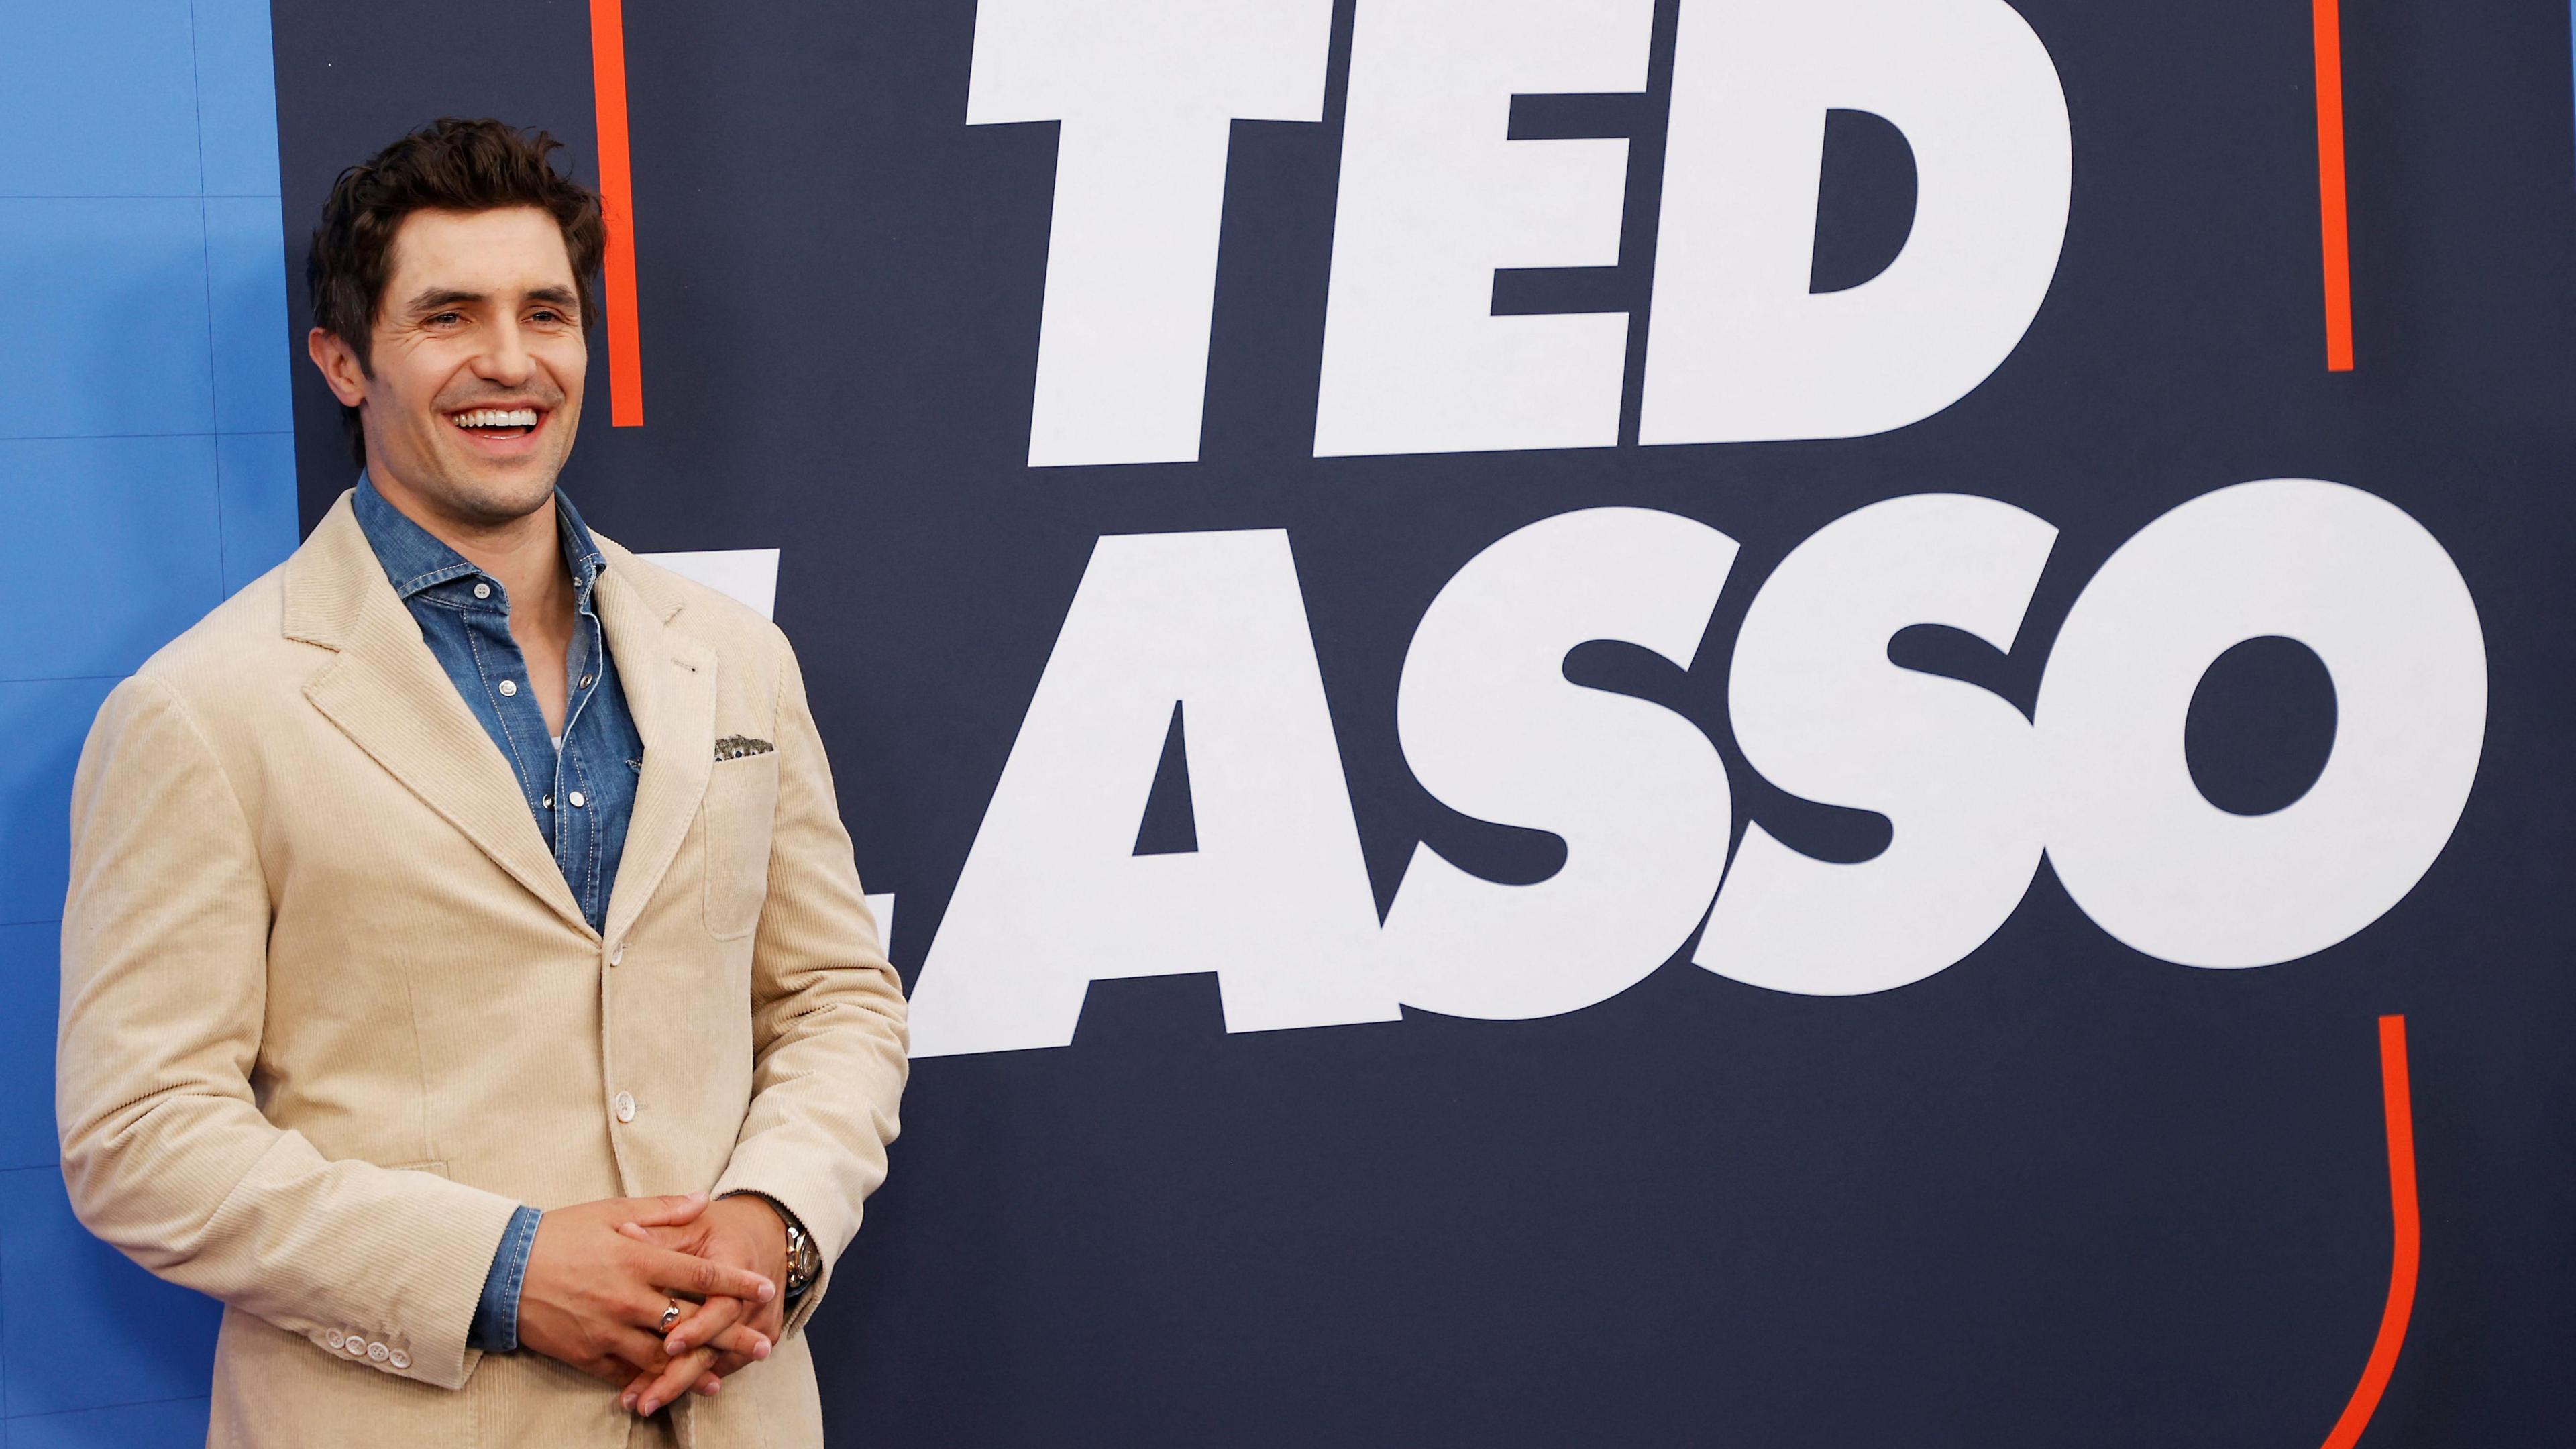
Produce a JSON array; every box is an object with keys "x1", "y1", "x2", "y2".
[{"x1": 246, "y1": 0, "x2": 2576, "y2": 1449}]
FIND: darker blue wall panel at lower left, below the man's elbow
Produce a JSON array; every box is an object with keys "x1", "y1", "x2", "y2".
[{"x1": 0, "y1": 1168, "x2": 221, "y2": 1418}]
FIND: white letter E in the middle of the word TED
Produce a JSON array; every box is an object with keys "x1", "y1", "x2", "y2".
[{"x1": 1313, "y1": 0, "x2": 1654, "y2": 456}]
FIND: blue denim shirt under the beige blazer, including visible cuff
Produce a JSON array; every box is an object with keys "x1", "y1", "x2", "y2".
[{"x1": 353, "y1": 474, "x2": 644, "y2": 1354}]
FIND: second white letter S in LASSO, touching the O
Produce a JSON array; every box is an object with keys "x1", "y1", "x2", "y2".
[{"x1": 1690, "y1": 492, "x2": 2058, "y2": 996}]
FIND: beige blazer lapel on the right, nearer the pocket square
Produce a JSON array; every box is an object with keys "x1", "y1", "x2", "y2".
[{"x1": 590, "y1": 536, "x2": 716, "y2": 941}]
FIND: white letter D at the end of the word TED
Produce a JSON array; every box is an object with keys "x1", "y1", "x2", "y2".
[{"x1": 1638, "y1": 0, "x2": 2074, "y2": 443}]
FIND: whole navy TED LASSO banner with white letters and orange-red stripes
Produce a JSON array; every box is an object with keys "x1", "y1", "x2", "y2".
[{"x1": 276, "y1": 0, "x2": 2576, "y2": 1449}]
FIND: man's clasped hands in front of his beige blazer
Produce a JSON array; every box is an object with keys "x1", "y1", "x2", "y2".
[{"x1": 518, "y1": 1194, "x2": 788, "y2": 1413}]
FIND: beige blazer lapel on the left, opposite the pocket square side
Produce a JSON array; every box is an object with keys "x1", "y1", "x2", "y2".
[{"x1": 286, "y1": 495, "x2": 590, "y2": 933}]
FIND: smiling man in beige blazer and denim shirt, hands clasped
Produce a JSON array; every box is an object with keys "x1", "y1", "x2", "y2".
[{"x1": 56, "y1": 121, "x2": 904, "y2": 1446}]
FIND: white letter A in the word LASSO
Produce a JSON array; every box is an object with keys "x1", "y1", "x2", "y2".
[{"x1": 912, "y1": 531, "x2": 1399, "y2": 1057}]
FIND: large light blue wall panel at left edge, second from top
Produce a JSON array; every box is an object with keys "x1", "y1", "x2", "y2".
[{"x1": 0, "y1": 199, "x2": 214, "y2": 438}]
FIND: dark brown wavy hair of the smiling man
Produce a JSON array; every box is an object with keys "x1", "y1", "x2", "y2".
[{"x1": 304, "y1": 116, "x2": 608, "y2": 467}]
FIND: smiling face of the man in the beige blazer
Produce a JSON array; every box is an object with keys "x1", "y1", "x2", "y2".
[{"x1": 314, "y1": 206, "x2": 590, "y2": 526}]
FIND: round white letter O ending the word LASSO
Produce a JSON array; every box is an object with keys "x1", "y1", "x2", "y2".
[{"x1": 2037, "y1": 480, "x2": 2486, "y2": 967}]
